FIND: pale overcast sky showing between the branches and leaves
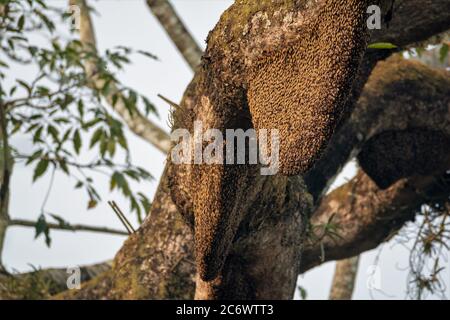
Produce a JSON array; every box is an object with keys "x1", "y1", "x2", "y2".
[{"x1": 3, "y1": 0, "x2": 450, "y2": 299}]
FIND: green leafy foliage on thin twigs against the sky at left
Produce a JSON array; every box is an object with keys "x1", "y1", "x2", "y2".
[{"x1": 0, "y1": 0, "x2": 156, "y2": 245}]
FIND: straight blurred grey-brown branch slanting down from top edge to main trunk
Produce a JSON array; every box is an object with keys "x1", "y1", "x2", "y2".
[{"x1": 147, "y1": 0, "x2": 203, "y2": 71}]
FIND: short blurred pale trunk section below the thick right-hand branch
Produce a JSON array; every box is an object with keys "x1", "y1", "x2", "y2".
[{"x1": 330, "y1": 256, "x2": 359, "y2": 300}]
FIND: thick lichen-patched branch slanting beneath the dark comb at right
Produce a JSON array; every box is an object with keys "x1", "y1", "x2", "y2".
[{"x1": 300, "y1": 171, "x2": 450, "y2": 273}]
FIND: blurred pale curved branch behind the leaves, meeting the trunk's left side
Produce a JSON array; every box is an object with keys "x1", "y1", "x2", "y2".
[{"x1": 70, "y1": 0, "x2": 171, "y2": 153}]
